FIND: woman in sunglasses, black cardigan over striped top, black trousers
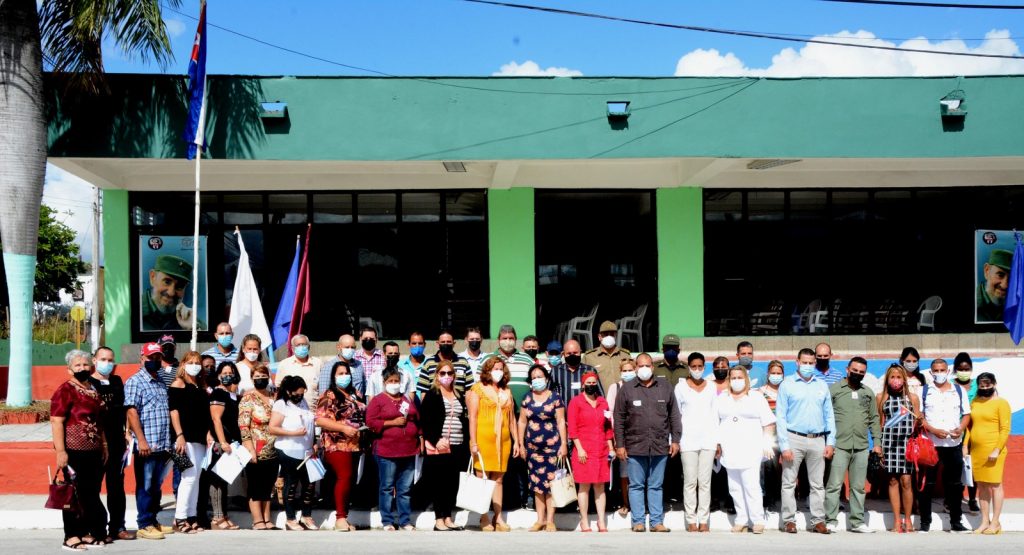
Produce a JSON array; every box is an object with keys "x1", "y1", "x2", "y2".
[{"x1": 420, "y1": 360, "x2": 469, "y2": 531}]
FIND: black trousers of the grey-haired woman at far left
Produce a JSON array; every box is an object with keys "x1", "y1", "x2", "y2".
[{"x1": 62, "y1": 450, "x2": 108, "y2": 541}]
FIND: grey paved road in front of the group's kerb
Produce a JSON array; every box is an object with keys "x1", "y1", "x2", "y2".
[{"x1": 14, "y1": 530, "x2": 1024, "y2": 555}]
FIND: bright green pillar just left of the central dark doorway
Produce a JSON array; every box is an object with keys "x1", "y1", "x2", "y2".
[{"x1": 487, "y1": 187, "x2": 537, "y2": 339}]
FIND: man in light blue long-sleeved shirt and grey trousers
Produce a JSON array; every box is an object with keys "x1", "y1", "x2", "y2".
[{"x1": 775, "y1": 348, "x2": 836, "y2": 533}]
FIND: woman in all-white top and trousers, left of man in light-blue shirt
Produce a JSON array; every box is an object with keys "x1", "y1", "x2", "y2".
[{"x1": 715, "y1": 367, "x2": 775, "y2": 533}]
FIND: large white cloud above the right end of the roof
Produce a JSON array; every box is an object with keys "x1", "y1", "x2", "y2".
[{"x1": 676, "y1": 30, "x2": 1024, "y2": 77}]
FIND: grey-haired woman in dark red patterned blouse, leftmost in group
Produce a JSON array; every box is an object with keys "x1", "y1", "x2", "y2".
[{"x1": 50, "y1": 350, "x2": 109, "y2": 551}]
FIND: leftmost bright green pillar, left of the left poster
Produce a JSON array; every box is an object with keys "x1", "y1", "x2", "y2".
[{"x1": 102, "y1": 188, "x2": 132, "y2": 352}]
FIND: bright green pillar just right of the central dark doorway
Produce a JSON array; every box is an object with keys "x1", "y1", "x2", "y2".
[{"x1": 655, "y1": 187, "x2": 703, "y2": 337}]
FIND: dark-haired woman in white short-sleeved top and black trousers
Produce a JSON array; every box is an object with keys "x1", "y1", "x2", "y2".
[{"x1": 269, "y1": 376, "x2": 319, "y2": 530}]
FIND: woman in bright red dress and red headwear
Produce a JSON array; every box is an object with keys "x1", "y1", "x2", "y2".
[{"x1": 568, "y1": 372, "x2": 612, "y2": 531}]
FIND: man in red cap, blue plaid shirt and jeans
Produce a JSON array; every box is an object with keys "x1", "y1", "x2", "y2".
[{"x1": 125, "y1": 343, "x2": 172, "y2": 538}]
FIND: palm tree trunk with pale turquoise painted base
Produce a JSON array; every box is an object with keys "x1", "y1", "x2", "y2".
[{"x1": 0, "y1": 0, "x2": 46, "y2": 407}]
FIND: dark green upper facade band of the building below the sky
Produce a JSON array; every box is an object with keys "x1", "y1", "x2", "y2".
[{"x1": 47, "y1": 75, "x2": 1024, "y2": 161}]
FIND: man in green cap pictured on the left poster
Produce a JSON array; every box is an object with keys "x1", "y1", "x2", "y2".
[{"x1": 141, "y1": 254, "x2": 206, "y2": 332}]
